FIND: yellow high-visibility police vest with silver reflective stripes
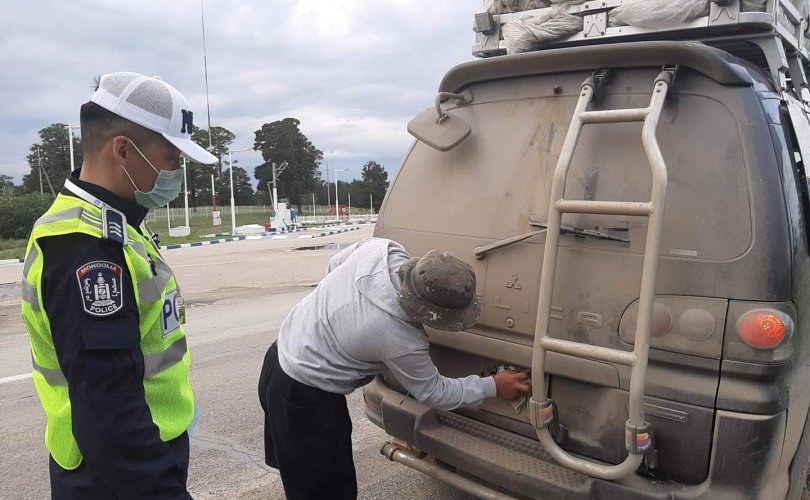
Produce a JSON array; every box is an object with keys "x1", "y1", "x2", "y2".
[{"x1": 22, "y1": 179, "x2": 194, "y2": 470}]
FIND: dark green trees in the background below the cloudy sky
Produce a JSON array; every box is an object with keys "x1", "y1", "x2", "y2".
[{"x1": 7, "y1": 118, "x2": 389, "y2": 212}]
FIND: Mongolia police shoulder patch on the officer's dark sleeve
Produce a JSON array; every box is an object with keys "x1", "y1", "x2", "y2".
[{"x1": 76, "y1": 260, "x2": 124, "y2": 317}]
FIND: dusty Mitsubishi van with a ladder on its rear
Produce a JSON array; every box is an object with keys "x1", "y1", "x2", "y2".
[{"x1": 364, "y1": 0, "x2": 810, "y2": 499}]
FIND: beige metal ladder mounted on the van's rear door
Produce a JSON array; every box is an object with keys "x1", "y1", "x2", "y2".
[{"x1": 529, "y1": 68, "x2": 676, "y2": 480}]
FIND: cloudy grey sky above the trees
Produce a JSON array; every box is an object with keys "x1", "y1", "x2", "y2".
[{"x1": 0, "y1": 0, "x2": 482, "y2": 183}]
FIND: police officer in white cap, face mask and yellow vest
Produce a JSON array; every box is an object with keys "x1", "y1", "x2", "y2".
[{"x1": 22, "y1": 73, "x2": 216, "y2": 499}]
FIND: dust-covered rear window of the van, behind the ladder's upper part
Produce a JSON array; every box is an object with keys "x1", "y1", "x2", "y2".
[{"x1": 385, "y1": 71, "x2": 752, "y2": 260}]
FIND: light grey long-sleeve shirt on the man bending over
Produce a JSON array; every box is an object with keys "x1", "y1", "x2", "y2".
[{"x1": 278, "y1": 238, "x2": 497, "y2": 409}]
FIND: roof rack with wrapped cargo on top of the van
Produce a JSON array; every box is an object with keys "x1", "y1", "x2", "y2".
[{"x1": 473, "y1": 0, "x2": 810, "y2": 102}]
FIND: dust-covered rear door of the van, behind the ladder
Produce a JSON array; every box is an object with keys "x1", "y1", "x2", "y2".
[{"x1": 377, "y1": 44, "x2": 779, "y2": 484}]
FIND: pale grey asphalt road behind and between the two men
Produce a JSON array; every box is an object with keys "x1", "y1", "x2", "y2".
[{"x1": 0, "y1": 226, "x2": 472, "y2": 500}]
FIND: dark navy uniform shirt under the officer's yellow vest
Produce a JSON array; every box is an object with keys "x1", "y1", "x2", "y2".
[{"x1": 39, "y1": 170, "x2": 191, "y2": 499}]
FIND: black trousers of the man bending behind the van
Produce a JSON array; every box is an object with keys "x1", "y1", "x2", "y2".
[{"x1": 259, "y1": 344, "x2": 357, "y2": 500}]
